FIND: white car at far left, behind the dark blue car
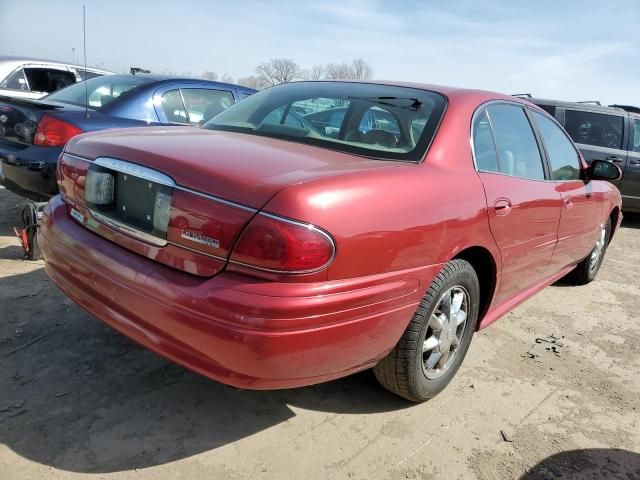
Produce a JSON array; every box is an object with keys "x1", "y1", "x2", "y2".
[{"x1": 0, "y1": 55, "x2": 112, "y2": 98}]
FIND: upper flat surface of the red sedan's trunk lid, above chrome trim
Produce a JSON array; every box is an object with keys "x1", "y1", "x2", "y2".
[{"x1": 65, "y1": 127, "x2": 397, "y2": 208}]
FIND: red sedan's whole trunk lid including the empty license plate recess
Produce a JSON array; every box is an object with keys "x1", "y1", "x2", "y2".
[{"x1": 58, "y1": 127, "x2": 389, "y2": 276}]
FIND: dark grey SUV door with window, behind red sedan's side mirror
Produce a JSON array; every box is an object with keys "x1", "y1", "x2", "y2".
[{"x1": 562, "y1": 108, "x2": 628, "y2": 187}]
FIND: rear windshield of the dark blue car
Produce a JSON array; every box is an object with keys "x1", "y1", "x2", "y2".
[{"x1": 45, "y1": 75, "x2": 154, "y2": 109}]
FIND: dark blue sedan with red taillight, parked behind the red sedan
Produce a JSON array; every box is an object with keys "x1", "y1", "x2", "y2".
[{"x1": 0, "y1": 75, "x2": 255, "y2": 201}]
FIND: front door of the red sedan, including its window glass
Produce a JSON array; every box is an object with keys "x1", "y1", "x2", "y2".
[{"x1": 531, "y1": 111, "x2": 604, "y2": 275}]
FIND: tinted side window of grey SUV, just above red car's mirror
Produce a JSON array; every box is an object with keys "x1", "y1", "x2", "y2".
[{"x1": 564, "y1": 109, "x2": 624, "y2": 150}]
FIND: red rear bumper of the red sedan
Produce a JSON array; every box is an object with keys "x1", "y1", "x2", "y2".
[{"x1": 39, "y1": 197, "x2": 441, "y2": 389}]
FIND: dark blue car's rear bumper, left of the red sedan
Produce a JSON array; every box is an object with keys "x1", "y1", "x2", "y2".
[{"x1": 0, "y1": 143, "x2": 62, "y2": 201}]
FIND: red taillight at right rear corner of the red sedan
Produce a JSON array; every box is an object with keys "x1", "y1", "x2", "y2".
[{"x1": 230, "y1": 213, "x2": 335, "y2": 273}]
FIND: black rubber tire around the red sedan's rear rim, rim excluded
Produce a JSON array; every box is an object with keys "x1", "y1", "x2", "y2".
[{"x1": 373, "y1": 260, "x2": 480, "y2": 402}]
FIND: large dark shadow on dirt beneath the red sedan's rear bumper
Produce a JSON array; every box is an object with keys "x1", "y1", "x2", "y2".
[{"x1": 0, "y1": 268, "x2": 410, "y2": 473}]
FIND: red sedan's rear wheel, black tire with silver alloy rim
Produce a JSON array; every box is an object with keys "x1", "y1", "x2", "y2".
[{"x1": 373, "y1": 260, "x2": 480, "y2": 402}]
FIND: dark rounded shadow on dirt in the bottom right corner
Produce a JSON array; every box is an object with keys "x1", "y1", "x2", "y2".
[{"x1": 520, "y1": 448, "x2": 640, "y2": 480}]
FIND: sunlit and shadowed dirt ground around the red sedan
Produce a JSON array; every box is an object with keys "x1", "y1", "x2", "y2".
[{"x1": 0, "y1": 187, "x2": 640, "y2": 480}]
